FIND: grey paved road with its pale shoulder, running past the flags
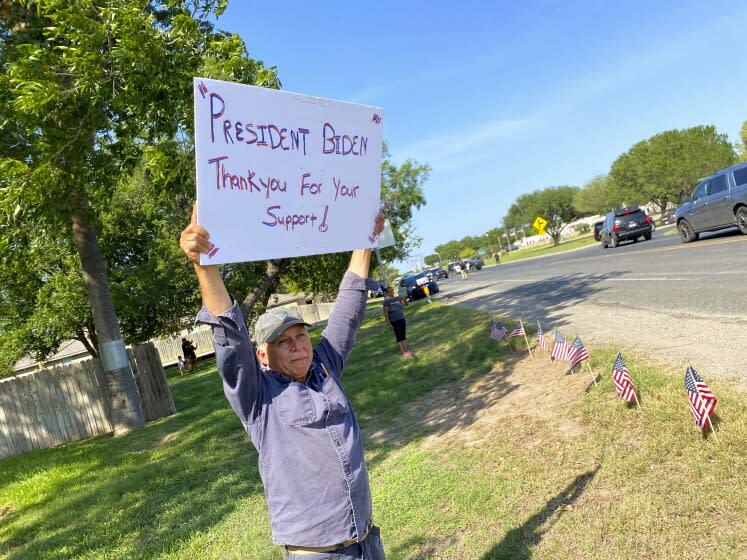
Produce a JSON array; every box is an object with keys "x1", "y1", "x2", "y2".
[{"x1": 439, "y1": 225, "x2": 747, "y2": 388}]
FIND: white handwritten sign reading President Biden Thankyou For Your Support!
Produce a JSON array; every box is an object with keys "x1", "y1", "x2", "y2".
[{"x1": 194, "y1": 78, "x2": 382, "y2": 264}]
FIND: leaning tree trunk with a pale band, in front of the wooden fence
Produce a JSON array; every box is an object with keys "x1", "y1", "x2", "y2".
[{"x1": 71, "y1": 197, "x2": 145, "y2": 435}]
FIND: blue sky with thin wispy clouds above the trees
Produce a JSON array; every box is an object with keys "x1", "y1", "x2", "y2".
[{"x1": 218, "y1": 0, "x2": 747, "y2": 268}]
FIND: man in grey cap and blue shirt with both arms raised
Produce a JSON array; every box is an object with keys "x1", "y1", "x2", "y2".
[{"x1": 180, "y1": 209, "x2": 385, "y2": 560}]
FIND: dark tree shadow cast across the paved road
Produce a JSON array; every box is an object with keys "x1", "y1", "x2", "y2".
[{"x1": 442, "y1": 271, "x2": 626, "y2": 332}]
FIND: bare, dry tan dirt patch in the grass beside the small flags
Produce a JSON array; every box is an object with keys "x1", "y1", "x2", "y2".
[{"x1": 371, "y1": 350, "x2": 593, "y2": 447}]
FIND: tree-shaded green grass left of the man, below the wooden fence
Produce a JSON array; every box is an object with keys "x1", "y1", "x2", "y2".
[{"x1": 0, "y1": 364, "x2": 262, "y2": 560}]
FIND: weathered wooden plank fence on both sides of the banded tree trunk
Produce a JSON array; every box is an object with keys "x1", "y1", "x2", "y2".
[{"x1": 0, "y1": 344, "x2": 176, "y2": 459}]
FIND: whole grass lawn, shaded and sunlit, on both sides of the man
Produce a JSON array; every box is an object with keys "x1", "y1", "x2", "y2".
[{"x1": 0, "y1": 302, "x2": 747, "y2": 560}]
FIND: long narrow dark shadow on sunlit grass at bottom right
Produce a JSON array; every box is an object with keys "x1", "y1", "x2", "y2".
[{"x1": 481, "y1": 465, "x2": 601, "y2": 560}]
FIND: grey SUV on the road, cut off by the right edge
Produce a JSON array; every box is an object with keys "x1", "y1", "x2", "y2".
[{"x1": 674, "y1": 163, "x2": 747, "y2": 243}]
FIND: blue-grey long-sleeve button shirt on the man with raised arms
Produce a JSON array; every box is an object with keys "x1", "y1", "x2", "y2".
[{"x1": 197, "y1": 272, "x2": 375, "y2": 546}]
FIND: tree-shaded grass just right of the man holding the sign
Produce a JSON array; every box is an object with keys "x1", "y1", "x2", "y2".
[{"x1": 343, "y1": 302, "x2": 525, "y2": 467}]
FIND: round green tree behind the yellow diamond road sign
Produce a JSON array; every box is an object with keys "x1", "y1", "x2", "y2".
[{"x1": 503, "y1": 186, "x2": 581, "y2": 245}]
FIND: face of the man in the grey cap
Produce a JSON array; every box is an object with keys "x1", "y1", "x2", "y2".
[{"x1": 257, "y1": 325, "x2": 313, "y2": 383}]
